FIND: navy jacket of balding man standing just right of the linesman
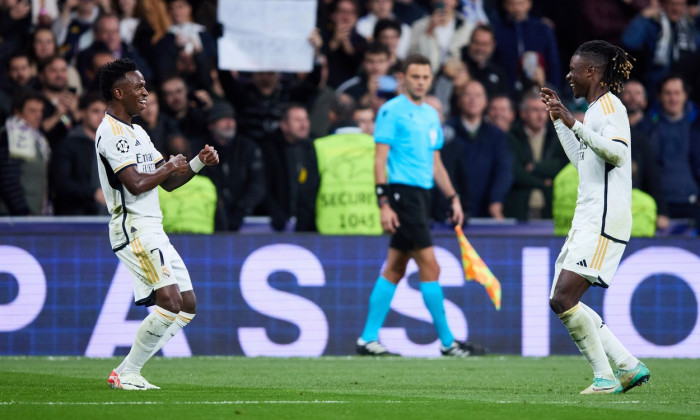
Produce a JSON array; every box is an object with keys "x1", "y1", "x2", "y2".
[{"x1": 447, "y1": 117, "x2": 513, "y2": 217}]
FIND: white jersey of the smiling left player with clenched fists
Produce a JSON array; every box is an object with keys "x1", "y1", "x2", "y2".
[{"x1": 95, "y1": 114, "x2": 163, "y2": 250}]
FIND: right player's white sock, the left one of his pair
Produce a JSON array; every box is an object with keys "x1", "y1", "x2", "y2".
[{"x1": 558, "y1": 302, "x2": 615, "y2": 380}]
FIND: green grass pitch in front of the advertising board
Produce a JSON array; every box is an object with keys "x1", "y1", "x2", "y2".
[{"x1": 0, "y1": 356, "x2": 700, "y2": 420}]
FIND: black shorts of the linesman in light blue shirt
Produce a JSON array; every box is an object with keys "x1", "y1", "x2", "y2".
[{"x1": 389, "y1": 184, "x2": 433, "y2": 252}]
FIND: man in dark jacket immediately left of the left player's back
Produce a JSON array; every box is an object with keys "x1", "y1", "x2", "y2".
[{"x1": 50, "y1": 92, "x2": 107, "y2": 216}]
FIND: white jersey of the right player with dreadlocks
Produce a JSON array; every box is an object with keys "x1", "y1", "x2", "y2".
[{"x1": 571, "y1": 92, "x2": 632, "y2": 242}]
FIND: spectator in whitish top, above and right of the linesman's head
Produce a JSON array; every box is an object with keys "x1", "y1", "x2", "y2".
[{"x1": 409, "y1": 0, "x2": 474, "y2": 73}]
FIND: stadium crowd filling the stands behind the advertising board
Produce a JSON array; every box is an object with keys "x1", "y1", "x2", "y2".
[{"x1": 0, "y1": 0, "x2": 700, "y2": 234}]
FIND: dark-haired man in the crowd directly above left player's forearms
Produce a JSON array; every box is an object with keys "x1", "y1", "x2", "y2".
[{"x1": 160, "y1": 76, "x2": 212, "y2": 150}]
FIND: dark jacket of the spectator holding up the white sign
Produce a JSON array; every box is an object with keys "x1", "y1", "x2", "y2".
[{"x1": 219, "y1": 65, "x2": 321, "y2": 142}]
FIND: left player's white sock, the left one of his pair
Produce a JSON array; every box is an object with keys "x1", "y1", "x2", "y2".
[{"x1": 117, "y1": 306, "x2": 177, "y2": 374}]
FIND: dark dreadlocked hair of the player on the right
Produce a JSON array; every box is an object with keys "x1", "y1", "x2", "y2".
[{"x1": 574, "y1": 40, "x2": 634, "y2": 93}]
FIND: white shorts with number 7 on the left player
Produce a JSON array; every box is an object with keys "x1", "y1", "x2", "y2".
[{"x1": 116, "y1": 233, "x2": 192, "y2": 302}]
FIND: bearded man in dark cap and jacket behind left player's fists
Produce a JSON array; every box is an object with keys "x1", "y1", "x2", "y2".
[{"x1": 202, "y1": 101, "x2": 265, "y2": 231}]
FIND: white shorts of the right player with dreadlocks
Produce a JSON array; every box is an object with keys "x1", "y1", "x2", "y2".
[{"x1": 549, "y1": 229, "x2": 626, "y2": 298}]
